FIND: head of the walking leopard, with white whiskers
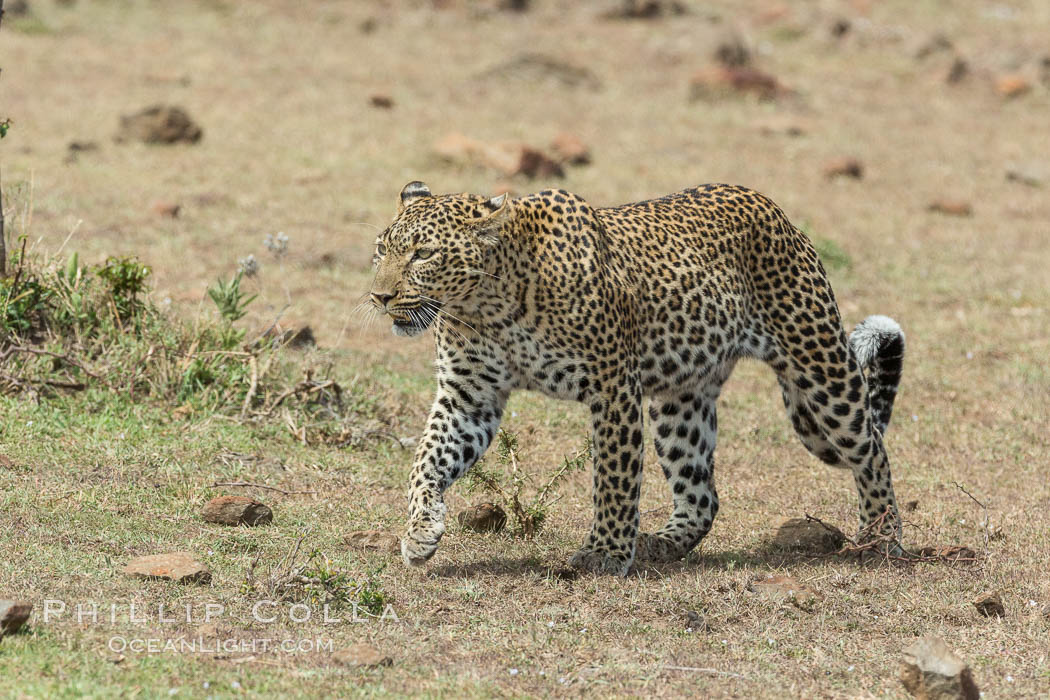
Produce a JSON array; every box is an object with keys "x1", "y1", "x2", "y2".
[{"x1": 371, "y1": 182, "x2": 513, "y2": 336}]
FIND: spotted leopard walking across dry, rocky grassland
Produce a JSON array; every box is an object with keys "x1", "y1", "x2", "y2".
[{"x1": 365, "y1": 181, "x2": 904, "y2": 576}]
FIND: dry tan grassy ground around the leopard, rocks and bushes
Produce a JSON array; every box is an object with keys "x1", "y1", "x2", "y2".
[{"x1": 0, "y1": 0, "x2": 1050, "y2": 698}]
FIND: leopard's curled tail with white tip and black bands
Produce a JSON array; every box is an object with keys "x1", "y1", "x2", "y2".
[{"x1": 849, "y1": 316, "x2": 904, "y2": 434}]
